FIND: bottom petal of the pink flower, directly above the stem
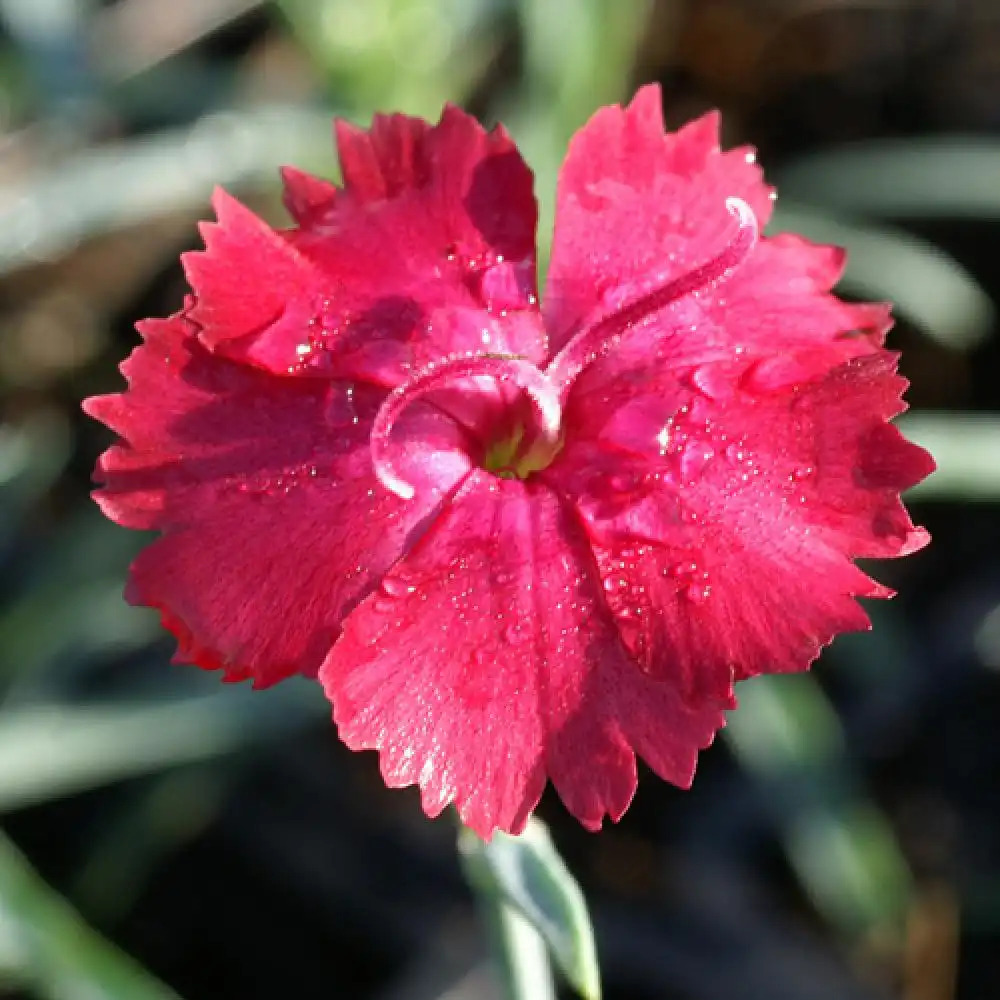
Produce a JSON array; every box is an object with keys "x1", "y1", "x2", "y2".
[{"x1": 320, "y1": 472, "x2": 723, "y2": 836}]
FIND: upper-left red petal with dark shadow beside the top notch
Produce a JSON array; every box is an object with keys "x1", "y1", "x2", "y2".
[{"x1": 184, "y1": 107, "x2": 545, "y2": 386}]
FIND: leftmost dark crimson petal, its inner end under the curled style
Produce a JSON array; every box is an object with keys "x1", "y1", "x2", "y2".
[{"x1": 86, "y1": 316, "x2": 468, "y2": 685}]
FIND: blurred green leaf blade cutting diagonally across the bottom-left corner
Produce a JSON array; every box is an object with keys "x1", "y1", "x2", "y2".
[{"x1": 0, "y1": 833, "x2": 177, "y2": 1000}]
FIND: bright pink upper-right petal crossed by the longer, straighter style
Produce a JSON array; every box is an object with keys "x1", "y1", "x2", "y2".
[{"x1": 545, "y1": 87, "x2": 892, "y2": 386}]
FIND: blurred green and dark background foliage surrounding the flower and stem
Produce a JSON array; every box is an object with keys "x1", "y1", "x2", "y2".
[{"x1": 0, "y1": 0, "x2": 1000, "y2": 1000}]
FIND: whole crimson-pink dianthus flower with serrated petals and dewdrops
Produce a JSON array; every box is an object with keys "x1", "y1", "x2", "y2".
[{"x1": 86, "y1": 87, "x2": 933, "y2": 835}]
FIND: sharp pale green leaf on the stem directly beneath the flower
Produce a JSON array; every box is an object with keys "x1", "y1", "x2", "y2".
[{"x1": 459, "y1": 818, "x2": 601, "y2": 1000}]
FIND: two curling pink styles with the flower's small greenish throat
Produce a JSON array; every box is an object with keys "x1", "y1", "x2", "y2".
[{"x1": 371, "y1": 198, "x2": 758, "y2": 500}]
